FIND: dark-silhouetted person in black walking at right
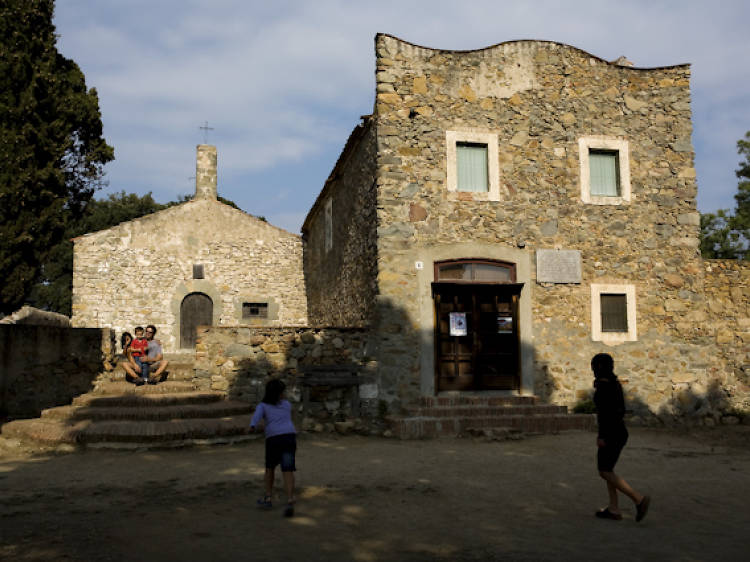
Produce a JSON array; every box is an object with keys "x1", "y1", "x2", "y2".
[{"x1": 591, "y1": 353, "x2": 651, "y2": 521}]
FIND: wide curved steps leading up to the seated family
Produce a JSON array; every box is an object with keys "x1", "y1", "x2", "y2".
[{"x1": 2, "y1": 356, "x2": 254, "y2": 449}]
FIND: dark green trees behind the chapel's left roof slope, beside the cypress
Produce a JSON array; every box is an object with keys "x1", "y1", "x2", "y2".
[{"x1": 29, "y1": 191, "x2": 171, "y2": 316}]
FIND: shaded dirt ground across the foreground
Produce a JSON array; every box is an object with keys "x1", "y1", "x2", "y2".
[{"x1": 0, "y1": 426, "x2": 750, "y2": 562}]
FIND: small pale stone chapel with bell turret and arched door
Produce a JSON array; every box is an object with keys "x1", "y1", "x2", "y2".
[{"x1": 72, "y1": 145, "x2": 307, "y2": 352}]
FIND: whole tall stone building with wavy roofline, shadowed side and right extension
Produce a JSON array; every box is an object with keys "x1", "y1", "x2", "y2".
[{"x1": 303, "y1": 34, "x2": 750, "y2": 415}]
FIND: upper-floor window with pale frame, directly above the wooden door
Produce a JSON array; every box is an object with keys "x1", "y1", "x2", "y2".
[{"x1": 445, "y1": 130, "x2": 500, "y2": 201}]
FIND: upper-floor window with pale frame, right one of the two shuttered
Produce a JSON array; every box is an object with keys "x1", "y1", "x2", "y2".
[{"x1": 578, "y1": 136, "x2": 631, "y2": 205}]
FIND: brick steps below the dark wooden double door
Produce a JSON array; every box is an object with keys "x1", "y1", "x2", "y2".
[{"x1": 387, "y1": 396, "x2": 596, "y2": 439}]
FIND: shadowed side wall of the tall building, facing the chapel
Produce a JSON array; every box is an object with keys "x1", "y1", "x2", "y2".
[{"x1": 303, "y1": 120, "x2": 377, "y2": 326}]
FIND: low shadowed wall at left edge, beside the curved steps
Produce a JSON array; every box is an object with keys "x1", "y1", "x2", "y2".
[{"x1": 0, "y1": 324, "x2": 115, "y2": 418}]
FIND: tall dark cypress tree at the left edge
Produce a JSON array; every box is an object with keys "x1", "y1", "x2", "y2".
[{"x1": 0, "y1": 0, "x2": 114, "y2": 314}]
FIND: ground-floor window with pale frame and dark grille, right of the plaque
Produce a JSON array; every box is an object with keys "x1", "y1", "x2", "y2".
[{"x1": 591, "y1": 283, "x2": 638, "y2": 343}]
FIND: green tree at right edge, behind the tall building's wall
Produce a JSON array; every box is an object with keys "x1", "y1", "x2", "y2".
[{"x1": 701, "y1": 131, "x2": 750, "y2": 260}]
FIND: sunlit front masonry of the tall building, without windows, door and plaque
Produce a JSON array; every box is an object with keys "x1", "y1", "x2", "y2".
[{"x1": 375, "y1": 35, "x2": 724, "y2": 412}]
